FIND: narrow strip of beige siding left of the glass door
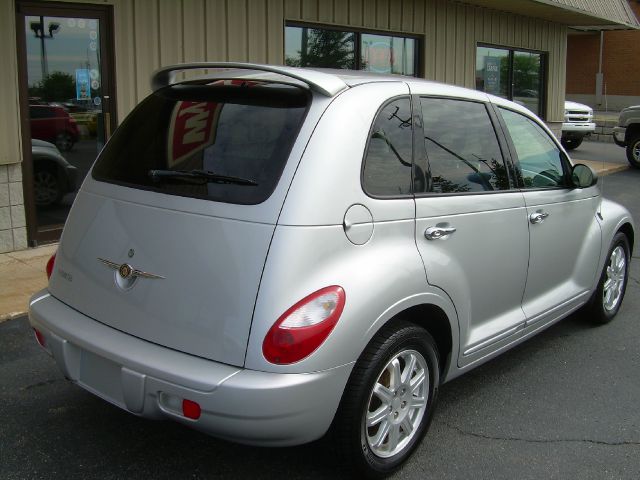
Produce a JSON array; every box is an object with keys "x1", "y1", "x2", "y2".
[{"x1": 0, "y1": 2, "x2": 22, "y2": 165}]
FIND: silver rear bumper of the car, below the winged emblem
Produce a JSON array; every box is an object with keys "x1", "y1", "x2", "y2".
[{"x1": 29, "y1": 290, "x2": 352, "y2": 446}]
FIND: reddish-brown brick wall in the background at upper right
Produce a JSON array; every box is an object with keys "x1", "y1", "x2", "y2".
[{"x1": 567, "y1": 0, "x2": 640, "y2": 96}]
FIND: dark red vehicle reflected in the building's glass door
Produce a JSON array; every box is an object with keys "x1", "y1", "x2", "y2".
[{"x1": 29, "y1": 105, "x2": 78, "y2": 152}]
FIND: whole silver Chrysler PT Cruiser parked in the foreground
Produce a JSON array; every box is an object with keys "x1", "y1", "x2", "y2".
[{"x1": 29, "y1": 63, "x2": 634, "y2": 477}]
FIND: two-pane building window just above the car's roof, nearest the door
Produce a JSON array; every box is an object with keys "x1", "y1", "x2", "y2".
[{"x1": 284, "y1": 25, "x2": 418, "y2": 76}]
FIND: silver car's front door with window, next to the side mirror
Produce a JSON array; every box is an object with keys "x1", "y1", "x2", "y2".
[{"x1": 498, "y1": 104, "x2": 602, "y2": 324}]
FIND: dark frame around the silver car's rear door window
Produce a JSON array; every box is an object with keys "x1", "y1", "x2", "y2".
[{"x1": 412, "y1": 94, "x2": 520, "y2": 198}]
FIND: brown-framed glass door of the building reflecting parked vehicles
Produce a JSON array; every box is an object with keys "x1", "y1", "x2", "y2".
[{"x1": 18, "y1": 2, "x2": 115, "y2": 245}]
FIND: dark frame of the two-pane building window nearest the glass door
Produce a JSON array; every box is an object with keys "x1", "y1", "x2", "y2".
[{"x1": 282, "y1": 20, "x2": 425, "y2": 78}]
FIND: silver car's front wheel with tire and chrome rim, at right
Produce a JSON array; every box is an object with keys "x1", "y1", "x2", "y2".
[{"x1": 586, "y1": 232, "x2": 631, "y2": 324}]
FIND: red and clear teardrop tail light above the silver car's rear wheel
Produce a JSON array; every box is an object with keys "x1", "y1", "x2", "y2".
[{"x1": 262, "y1": 286, "x2": 345, "y2": 365}]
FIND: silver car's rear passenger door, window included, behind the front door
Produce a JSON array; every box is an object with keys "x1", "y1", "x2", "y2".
[{"x1": 416, "y1": 97, "x2": 529, "y2": 366}]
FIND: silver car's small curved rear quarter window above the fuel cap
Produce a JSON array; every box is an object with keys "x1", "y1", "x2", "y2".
[{"x1": 363, "y1": 98, "x2": 413, "y2": 196}]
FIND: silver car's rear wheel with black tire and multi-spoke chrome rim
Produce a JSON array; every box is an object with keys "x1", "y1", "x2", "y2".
[{"x1": 332, "y1": 321, "x2": 440, "y2": 478}]
